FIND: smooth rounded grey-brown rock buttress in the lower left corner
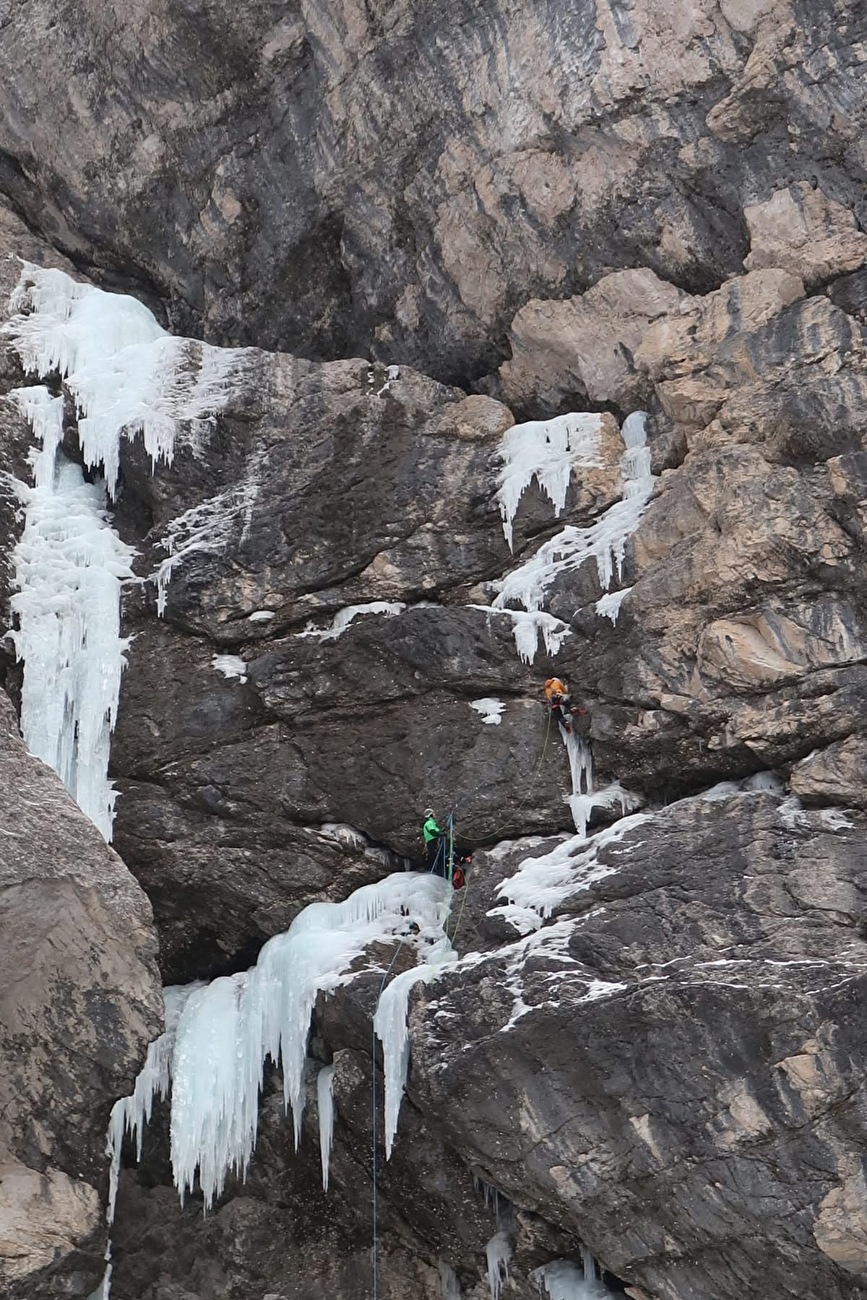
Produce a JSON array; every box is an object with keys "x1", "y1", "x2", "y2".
[{"x1": 0, "y1": 694, "x2": 161, "y2": 1300}]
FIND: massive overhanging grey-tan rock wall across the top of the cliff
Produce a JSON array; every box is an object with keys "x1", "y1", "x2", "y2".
[{"x1": 0, "y1": 0, "x2": 864, "y2": 382}]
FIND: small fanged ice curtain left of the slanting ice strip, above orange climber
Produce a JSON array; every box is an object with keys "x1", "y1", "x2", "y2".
[{"x1": 497, "y1": 412, "x2": 602, "y2": 547}]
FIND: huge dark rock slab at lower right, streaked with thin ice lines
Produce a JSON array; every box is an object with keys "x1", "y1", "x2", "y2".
[{"x1": 412, "y1": 794, "x2": 867, "y2": 1300}]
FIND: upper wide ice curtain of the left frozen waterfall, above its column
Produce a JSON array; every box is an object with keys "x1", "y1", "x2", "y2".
[{"x1": 4, "y1": 263, "x2": 243, "y2": 497}]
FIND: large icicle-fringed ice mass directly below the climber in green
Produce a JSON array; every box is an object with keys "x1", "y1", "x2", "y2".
[{"x1": 114, "y1": 871, "x2": 451, "y2": 1206}]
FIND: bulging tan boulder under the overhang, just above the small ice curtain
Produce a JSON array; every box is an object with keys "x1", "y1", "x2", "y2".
[{"x1": 499, "y1": 268, "x2": 689, "y2": 410}]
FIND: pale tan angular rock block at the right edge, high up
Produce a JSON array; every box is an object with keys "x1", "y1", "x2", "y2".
[{"x1": 744, "y1": 181, "x2": 867, "y2": 289}]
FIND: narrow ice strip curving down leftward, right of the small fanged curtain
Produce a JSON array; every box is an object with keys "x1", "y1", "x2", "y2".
[{"x1": 491, "y1": 411, "x2": 656, "y2": 612}]
